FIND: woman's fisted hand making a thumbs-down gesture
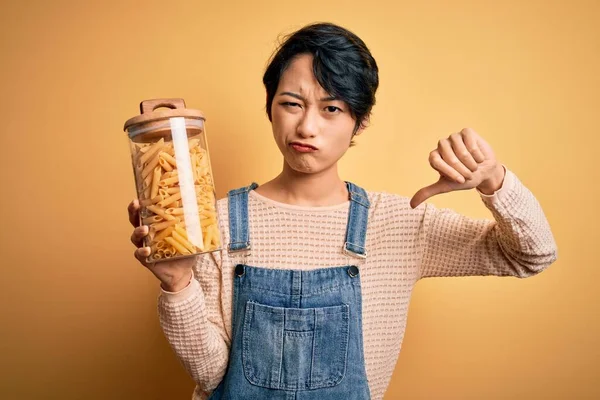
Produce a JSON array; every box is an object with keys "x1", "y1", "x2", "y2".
[{"x1": 410, "y1": 128, "x2": 505, "y2": 208}]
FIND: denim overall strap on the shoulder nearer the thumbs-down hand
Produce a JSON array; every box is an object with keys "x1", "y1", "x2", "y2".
[{"x1": 343, "y1": 182, "x2": 371, "y2": 258}]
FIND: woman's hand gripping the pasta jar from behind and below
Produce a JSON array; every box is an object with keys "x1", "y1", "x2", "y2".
[{"x1": 127, "y1": 199, "x2": 198, "y2": 292}]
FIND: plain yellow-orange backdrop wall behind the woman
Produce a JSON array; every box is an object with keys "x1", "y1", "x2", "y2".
[{"x1": 0, "y1": 0, "x2": 600, "y2": 399}]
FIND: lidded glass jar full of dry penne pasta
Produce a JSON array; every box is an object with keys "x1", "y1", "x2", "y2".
[{"x1": 124, "y1": 99, "x2": 222, "y2": 262}]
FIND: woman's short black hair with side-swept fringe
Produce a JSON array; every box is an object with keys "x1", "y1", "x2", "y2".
[{"x1": 263, "y1": 23, "x2": 379, "y2": 144}]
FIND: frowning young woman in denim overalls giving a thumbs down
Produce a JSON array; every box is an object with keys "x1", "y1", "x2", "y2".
[{"x1": 129, "y1": 24, "x2": 557, "y2": 400}]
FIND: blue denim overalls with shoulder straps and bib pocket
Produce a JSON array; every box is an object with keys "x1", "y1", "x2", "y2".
[{"x1": 209, "y1": 182, "x2": 370, "y2": 400}]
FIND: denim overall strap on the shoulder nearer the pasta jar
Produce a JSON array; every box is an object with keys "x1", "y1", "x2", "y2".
[{"x1": 227, "y1": 182, "x2": 258, "y2": 252}]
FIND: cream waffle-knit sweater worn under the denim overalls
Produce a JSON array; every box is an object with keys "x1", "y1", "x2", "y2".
[{"x1": 158, "y1": 169, "x2": 557, "y2": 400}]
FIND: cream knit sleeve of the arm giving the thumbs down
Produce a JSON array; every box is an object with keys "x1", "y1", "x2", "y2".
[{"x1": 420, "y1": 169, "x2": 557, "y2": 278}]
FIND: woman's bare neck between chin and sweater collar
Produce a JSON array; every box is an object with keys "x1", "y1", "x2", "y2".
[{"x1": 268, "y1": 161, "x2": 348, "y2": 207}]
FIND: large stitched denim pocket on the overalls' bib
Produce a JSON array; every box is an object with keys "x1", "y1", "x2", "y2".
[{"x1": 242, "y1": 302, "x2": 350, "y2": 390}]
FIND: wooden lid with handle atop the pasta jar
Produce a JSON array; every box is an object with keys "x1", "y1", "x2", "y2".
[{"x1": 123, "y1": 99, "x2": 206, "y2": 137}]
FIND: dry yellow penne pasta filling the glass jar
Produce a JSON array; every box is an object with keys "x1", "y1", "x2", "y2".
[{"x1": 133, "y1": 139, "x2": 221, "y2": 261}]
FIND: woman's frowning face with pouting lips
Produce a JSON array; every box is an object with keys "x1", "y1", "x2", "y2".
[{"x1": 271, "y1": 54, "x2": 356, "y2": 174}]
